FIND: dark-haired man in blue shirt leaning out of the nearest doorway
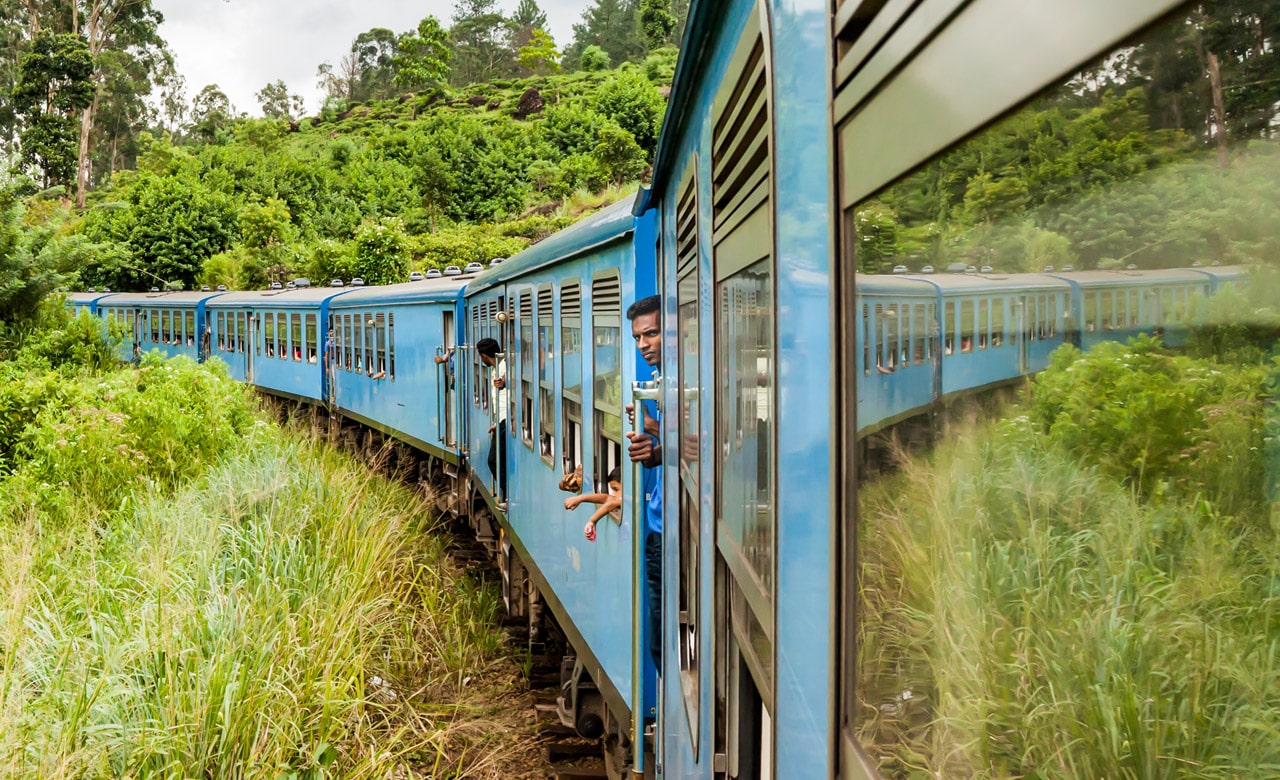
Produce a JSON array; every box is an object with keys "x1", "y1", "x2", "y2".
[{"x1": 627, "y1": 295, "x2": 662, "y2": 674}]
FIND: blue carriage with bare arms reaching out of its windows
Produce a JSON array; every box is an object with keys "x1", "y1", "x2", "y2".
[{"x1": 458, "y1": 199, "x2": 655, "y2": 756}]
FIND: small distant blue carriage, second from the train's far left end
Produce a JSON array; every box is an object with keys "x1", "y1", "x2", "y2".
[{"x1": 97, "y1": 289, "x2": 223, "y2": 362}]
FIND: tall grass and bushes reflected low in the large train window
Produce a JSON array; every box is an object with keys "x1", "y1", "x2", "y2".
[{"x1": 858, "y1": 418, "x2": 1280, "y2": 780}]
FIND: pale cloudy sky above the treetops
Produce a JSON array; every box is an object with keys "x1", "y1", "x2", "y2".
[{"x1": 152, "y1": 0, "x2": 590, "y2": 117}]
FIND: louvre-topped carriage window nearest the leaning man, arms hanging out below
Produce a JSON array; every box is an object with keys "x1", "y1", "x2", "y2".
[{"x1": 591, "y1": 272, "x2": 622, "y2": 493}]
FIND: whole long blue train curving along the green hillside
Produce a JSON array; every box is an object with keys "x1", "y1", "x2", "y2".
[{"x1": 60, "y1": 0, "x2": 1274, "y2": 779}]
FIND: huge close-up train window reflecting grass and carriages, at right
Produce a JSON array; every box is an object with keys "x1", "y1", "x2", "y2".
[{"x1": 839, "y1": 0, "x2": 1280, "y2": 777}]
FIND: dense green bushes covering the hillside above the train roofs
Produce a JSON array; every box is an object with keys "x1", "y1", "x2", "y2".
[{"x1": 60, "y1": 60, "x2": 671, "y2": 289}]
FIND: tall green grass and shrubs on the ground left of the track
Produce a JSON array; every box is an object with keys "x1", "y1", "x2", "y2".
[{"x1": 0, "y1": 330, "x2": 536, "y2": 777}]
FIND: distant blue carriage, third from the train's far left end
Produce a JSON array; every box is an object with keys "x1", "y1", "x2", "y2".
[{"x1": 207, "y1": 284, "x2": 352, "y2": 402}]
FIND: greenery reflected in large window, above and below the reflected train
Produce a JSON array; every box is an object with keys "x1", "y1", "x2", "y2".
[{"x1": 850, "y1": 1, "x2": 1280, "y2": 779}]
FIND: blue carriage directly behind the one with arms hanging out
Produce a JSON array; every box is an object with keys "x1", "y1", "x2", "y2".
[{"x1": 323, "y1": 270, "x2": 483, "y2": 466}]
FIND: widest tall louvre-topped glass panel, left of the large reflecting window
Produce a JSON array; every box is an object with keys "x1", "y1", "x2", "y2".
[{"x1": 709, "y1": 12, "x2": 777, "y2": 780}]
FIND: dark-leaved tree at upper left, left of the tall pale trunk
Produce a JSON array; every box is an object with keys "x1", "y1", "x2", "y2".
[{"x1": 13, "y1": 32, "x2": 93, "y2": 187}]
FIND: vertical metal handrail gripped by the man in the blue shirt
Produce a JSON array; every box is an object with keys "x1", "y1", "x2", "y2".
[{"x1": 631, "y1": 371, "x2": 662, "y2": 777}]
